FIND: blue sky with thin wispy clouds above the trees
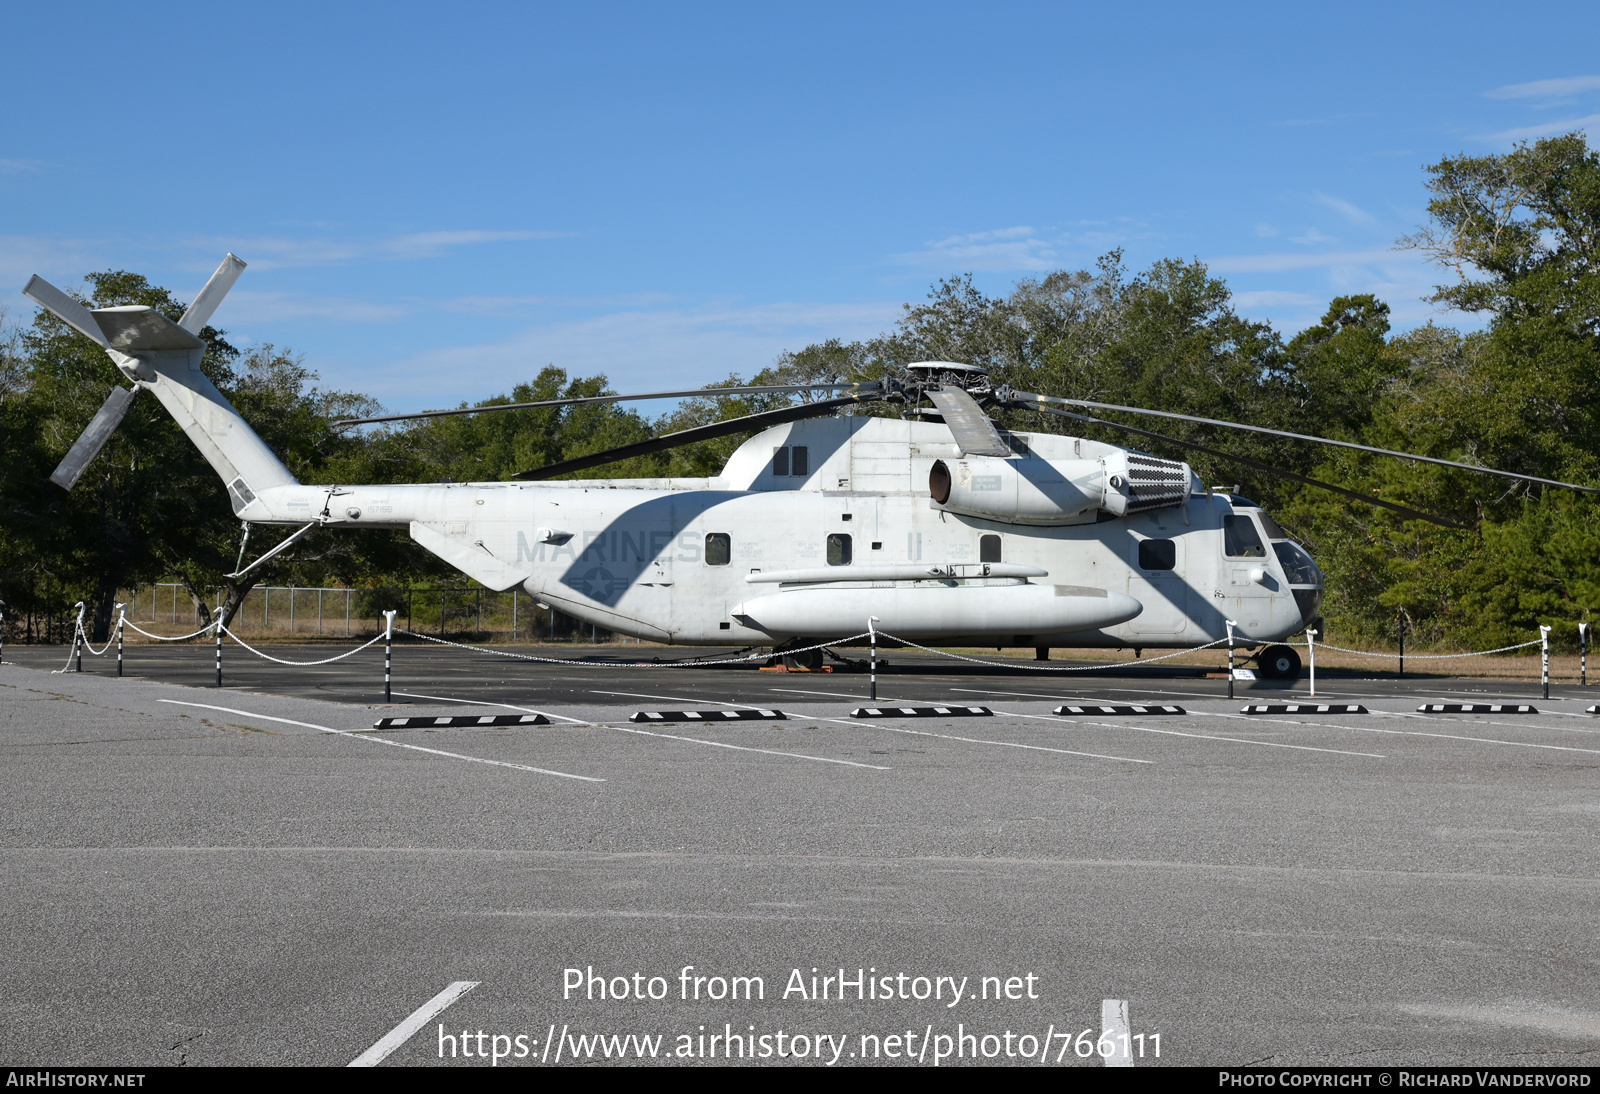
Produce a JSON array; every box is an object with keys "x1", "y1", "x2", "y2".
[{"x1": 0, "y1": 3, "x2": 1600, "y2": 409}]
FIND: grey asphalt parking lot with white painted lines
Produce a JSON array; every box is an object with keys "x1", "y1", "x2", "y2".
[{"x1": 0, "y1": 646, "x2": 1600, "y2": 1067}]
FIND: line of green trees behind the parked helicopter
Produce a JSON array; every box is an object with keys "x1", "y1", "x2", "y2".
[{"x1": 0, "y1": 133, "x2": 1600, "y2": 648}]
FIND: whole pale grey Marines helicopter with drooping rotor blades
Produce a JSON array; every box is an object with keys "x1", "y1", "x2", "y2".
[{"x1": 24, "y1": 254, "x2": 1600, "y2": 678}]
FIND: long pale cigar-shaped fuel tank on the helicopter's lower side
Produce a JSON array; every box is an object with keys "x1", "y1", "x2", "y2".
[{"x1": 731, "y1": 584, "x2": 1144, "y2": 638}]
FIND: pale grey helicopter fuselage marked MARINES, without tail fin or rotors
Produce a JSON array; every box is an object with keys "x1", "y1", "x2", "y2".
[{"x1": 235, "y1": 416, "x2": 1322, "y2": 648}]
